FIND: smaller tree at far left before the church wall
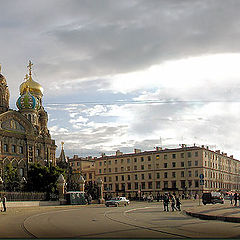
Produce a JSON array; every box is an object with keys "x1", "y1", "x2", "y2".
[{"x1": 3, "y1": 163, "x2": 20, "y2": 192}]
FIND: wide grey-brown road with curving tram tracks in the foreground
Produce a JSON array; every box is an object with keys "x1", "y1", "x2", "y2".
[{"x1": 0, "y1": 201, "x2": 240, "y2": 238}]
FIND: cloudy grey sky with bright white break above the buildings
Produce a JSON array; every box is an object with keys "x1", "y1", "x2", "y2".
[{"x1": 0, "y1": 0, "x2": 240, "y2": 159}]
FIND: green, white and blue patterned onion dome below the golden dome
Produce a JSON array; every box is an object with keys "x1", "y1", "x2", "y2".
[{"x1": 16, "y1": 88, "x2": 40, "y2": 110}]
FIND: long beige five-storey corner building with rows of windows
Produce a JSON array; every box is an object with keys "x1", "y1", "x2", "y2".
[{"x1": 94, "y1": 145, "x2": 240, "y2": 197}]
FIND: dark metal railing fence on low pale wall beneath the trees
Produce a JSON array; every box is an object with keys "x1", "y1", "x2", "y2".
[{"x1": 0, "y1": 192, "x2": 47, "y2": 201}]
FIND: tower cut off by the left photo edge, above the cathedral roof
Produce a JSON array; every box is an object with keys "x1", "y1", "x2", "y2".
[{"x1": 0, "y1": 65, "x2": 10, "y2": 114}]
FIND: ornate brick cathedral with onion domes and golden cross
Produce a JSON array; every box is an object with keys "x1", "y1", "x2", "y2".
[{"x1": 0, "y1": 61, "x2": 57, "y2": 177}]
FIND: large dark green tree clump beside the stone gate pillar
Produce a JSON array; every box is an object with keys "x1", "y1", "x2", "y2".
[{"x1": 26, "y1": 163, "x2": 64, "y2": 199}]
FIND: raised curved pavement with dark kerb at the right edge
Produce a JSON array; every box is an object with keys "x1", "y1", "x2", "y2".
[{"x1": 184, "y1": 202, "x2": 240, "y2": 223}]
